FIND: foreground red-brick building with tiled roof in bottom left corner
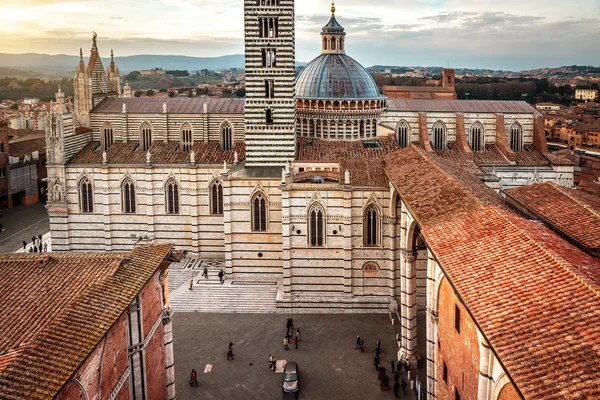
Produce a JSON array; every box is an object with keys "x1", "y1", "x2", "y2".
[{"x1": 0, "y1": 244, "x2": 181, "y2": 400}]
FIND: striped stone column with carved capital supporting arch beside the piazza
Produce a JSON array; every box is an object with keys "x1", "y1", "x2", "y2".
[{"x1": 398, "y1": 251, "x2": 418, "y2": 368}]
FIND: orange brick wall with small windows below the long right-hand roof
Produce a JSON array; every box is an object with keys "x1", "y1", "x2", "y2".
[{"x1": 437, "y1": 279, "x2": 479, "y2": 400}]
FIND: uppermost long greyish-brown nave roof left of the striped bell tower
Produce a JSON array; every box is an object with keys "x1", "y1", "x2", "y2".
[{"x1": 91, "y1": 97, "x2": 245, "y2": 114}]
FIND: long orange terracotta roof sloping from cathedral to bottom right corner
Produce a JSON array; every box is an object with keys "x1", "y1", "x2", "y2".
[{"x1": 385, "y1": 146, "x2": 600, "y2": 399}]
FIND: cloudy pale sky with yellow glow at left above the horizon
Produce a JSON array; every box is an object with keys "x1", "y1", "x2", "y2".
[{"x1": 0, "y1": 0, "x2": 600, "y2": 70}]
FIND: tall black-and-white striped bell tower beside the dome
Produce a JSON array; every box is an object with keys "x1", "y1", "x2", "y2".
[{"x1": 244, "y1": 0, "x2": 296, "y2": 167}]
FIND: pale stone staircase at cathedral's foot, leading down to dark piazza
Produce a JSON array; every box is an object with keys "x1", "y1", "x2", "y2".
[{"x1": 169, "y1": 259, "x2": 278, "y2": 313}]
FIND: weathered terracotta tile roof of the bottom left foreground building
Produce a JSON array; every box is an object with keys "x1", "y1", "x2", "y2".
[{"x1": 0, "y1": 244, "x2": 172, "y2": 399}]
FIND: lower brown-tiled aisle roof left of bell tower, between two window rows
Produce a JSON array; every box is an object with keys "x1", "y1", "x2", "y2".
[{"x1": 71, "y1": 141, "x2": 246, "y2": 165}]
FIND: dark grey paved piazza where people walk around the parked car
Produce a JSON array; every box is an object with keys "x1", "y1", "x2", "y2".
[{"x1": 173, "y1": 313, "x2": 414, "y2": 400}]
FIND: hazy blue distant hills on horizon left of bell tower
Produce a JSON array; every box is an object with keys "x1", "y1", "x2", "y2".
[{"x1": 0, "y1": 53, "x2": 244, "y2": 74}]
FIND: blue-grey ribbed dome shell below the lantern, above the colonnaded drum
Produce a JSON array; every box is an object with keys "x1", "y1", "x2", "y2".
[{"x1": 296, "y1": 53, "x2": 383, "y2": 100}]
